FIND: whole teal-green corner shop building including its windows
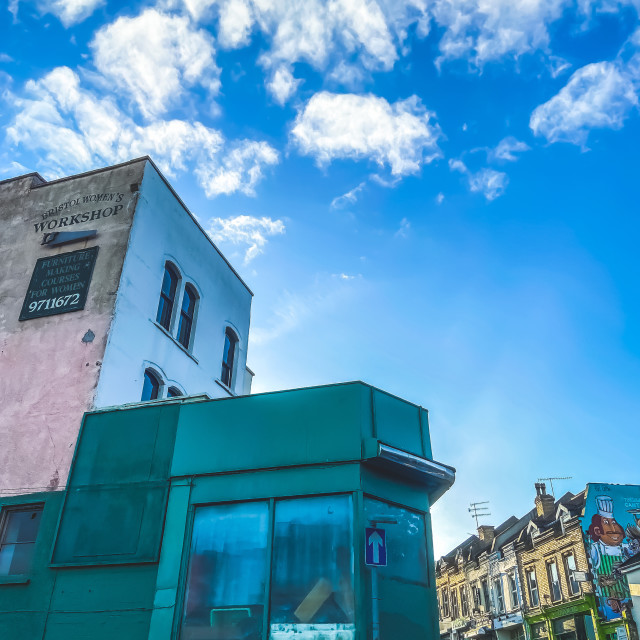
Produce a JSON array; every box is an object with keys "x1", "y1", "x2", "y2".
[{"x1": 0, "y1": 382, "x2": 455, "y2": 640}]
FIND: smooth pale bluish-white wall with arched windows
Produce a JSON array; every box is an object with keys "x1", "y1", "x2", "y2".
[{"x1": 95, "y1": 163, "x2": 251, "y2": 407}]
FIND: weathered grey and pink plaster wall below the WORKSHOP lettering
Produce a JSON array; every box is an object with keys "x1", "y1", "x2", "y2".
[{"x1": 0, "y1": 160, "x2": 146, "y2": 493}]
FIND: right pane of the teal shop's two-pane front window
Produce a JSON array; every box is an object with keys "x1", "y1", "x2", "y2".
[{"x1": 270, "y1": 496, "x2": 355, "y2": 640}]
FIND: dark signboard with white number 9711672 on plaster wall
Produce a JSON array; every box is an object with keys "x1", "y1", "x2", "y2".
[{"x1": 20, "y1": 247, "x2": 98, "y2": 320}]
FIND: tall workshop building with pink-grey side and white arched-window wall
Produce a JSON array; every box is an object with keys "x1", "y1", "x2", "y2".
[{"x1": 0, "y1": 157, "x2": 252, "y2": 493}]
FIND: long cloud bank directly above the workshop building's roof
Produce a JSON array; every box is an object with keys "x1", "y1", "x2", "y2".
[{"x1": 7, "y1": 67, "x2": 278, "y2": 197}]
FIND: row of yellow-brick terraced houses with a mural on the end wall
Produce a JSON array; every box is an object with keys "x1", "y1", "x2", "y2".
[{"x1": 436, "y1": 483, "x2": 640, "y2": 640}]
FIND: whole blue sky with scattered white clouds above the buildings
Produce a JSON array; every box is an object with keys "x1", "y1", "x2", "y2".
[{"x1": 0, "y1": 0, "x2": 640, "y2": 554}]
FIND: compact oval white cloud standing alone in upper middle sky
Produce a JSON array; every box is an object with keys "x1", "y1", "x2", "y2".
[{"x1": 291, "y1": 91, "x2": 441, "y2": 176}]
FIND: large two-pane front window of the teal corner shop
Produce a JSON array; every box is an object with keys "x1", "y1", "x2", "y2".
[{"x1": 180, "y1": 495, "x2": 355, "y2": 640}]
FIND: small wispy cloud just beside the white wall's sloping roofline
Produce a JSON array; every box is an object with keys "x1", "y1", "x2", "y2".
[{"x1": 207, "y1": 215, "x2": 286, "y2": 264}]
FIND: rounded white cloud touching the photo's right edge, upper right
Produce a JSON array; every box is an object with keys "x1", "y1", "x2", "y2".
[{"x1": 529, "y1": 62, "x2": 638, "y2": 146}]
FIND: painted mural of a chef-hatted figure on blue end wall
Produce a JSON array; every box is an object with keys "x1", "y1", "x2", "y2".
[{"x1": 582, "y1": 484, "x2": 640, "y2": 620}]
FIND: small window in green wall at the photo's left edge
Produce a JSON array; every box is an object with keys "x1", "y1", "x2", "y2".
[{"x1": 0, "y1": 505, "x2": 42, "y2": 577}]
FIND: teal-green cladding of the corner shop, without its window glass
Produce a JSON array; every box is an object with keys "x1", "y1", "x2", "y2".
[{"x1": 0, "y1": 382, "x2": 444, "y2": 640}]
